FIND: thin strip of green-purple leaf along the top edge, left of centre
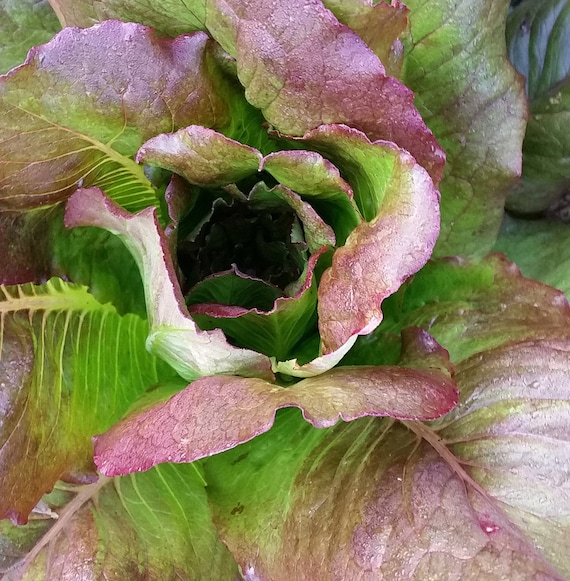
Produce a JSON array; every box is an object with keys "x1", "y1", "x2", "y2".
[{"x1": 49, "y1": 0, "x2": 207, "y2": 36}]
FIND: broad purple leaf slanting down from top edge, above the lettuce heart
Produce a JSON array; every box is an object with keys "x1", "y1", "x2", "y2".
[{"x1": 206, "y1": 0, "x2": 445, "y2": 184}]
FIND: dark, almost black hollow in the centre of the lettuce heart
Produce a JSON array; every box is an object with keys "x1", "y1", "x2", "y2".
[{"x1": 178, "y1": 200, "x2": 306, "y2": 292}]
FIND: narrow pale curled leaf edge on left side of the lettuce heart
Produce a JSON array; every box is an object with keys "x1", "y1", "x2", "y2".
[{"x1": 65, "y1": 188, "x2": 272, "y2": 381}]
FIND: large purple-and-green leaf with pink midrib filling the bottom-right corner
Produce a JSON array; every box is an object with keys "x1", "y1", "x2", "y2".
[{"x1": 205, "y1": 330, "x2": 570, "y2": 581}]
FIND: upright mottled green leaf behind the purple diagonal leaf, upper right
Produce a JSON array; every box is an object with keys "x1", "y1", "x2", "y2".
[{"x1": 401, "y1": 0, "x2": 526, "y2": 256}]
